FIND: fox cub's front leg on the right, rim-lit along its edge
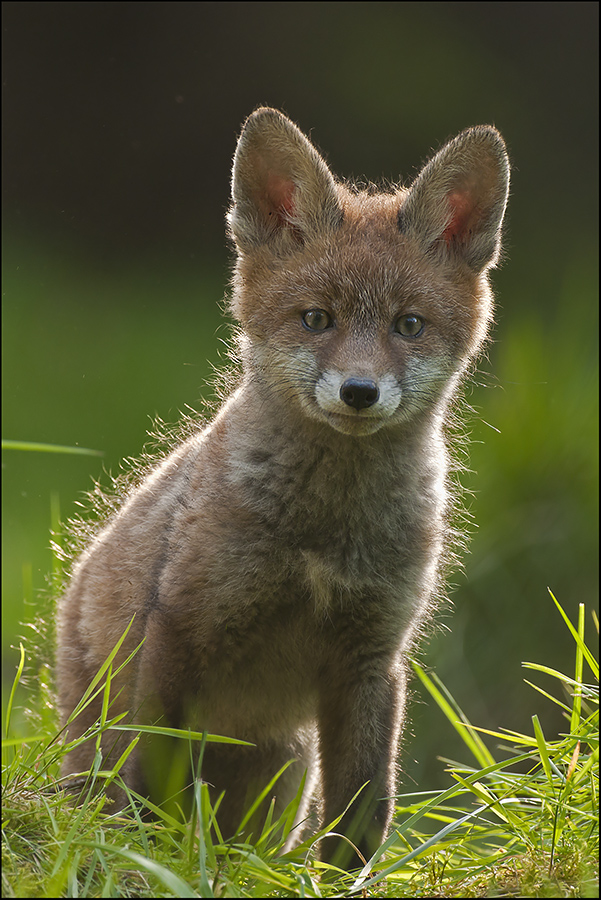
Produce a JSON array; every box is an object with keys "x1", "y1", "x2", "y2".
[{"x1": 319, "y1": 657, "x2": 405, "y2": 868}]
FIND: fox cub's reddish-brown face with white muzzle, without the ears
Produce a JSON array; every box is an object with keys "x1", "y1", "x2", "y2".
[{"x1": 241, "y1": 198, "x2": 486, "y2": 436}]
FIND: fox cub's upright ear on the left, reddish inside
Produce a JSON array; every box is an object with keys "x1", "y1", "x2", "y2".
[{"x1": 228, "y1": 107, "x2": 342, "y2": 252}]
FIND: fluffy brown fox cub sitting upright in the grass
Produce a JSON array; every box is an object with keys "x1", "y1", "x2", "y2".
[{"x1": 58, "y1": 108, "x2": 509, "y2": 865}]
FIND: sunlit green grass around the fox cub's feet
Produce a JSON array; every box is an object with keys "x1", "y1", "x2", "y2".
[{"x1": 2, "y1": 598, "x2": 599, "y2": 897}]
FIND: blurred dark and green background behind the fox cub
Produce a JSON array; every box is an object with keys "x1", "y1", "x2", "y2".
[{"x1": 2, "y1": 0, "x2": 598, "y2": 790}]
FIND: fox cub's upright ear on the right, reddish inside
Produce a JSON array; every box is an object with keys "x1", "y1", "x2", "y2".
[{"x1": 399, "y1": 125, "x2": 509, "y2": 272}]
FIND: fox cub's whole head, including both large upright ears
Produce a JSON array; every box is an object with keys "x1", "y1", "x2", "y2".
[{"x1": 228, "y1": 108, "x2": 509, "y2": 436}]
